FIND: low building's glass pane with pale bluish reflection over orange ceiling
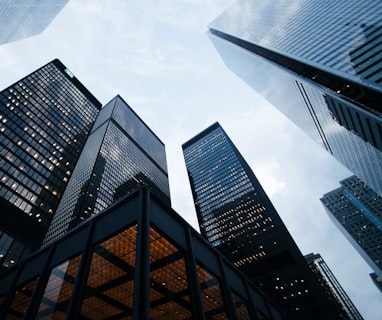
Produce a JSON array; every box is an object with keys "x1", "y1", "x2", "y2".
[{"x1": 37, "y1": 255, "x2": 81, "y2": 319}]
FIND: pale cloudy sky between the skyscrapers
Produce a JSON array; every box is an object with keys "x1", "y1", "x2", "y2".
[{"x1": 0, "y1": 0, "x2": 382, "y2": 319}]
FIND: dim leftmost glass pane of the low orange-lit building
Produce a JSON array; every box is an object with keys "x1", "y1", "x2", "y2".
[{"x1": 5, "y1": 277, "x2": 38, "y2": 320}]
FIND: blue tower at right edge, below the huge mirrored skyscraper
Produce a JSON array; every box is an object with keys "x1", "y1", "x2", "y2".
[{"x1": 321, "y1": 176, "x2": 382, "y2": 278}]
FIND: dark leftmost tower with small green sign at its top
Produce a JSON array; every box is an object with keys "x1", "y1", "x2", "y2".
[{"x1": 0, "y1": 60, "x2": 101, "y2": 267}]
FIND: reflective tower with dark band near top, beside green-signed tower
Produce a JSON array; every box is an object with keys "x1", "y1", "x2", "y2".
[{"x1": 44, "y1": 95, "x2": 170, "y2": 244}]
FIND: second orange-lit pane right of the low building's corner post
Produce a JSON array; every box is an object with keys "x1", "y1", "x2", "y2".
[{"x1": 196, "y1": 264, "x2": 228, "y2": 320}]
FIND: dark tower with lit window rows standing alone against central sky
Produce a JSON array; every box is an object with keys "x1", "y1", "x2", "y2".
[{"x1": 183, "y1": 123, "x2": 346, "y2": 319}]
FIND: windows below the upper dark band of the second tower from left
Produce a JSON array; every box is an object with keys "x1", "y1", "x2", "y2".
[{"x1": 47, "y1": 117, "x2": 169, "y2": 242}]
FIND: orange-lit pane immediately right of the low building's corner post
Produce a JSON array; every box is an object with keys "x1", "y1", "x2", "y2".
[{"x1": 150, "y1": 228, "x2": 192, "y2": 320}]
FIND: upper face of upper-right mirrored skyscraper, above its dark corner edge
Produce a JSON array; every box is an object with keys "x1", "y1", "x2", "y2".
[{"x1": 211, "y1": 0, "x2": 382, "y2": 90}]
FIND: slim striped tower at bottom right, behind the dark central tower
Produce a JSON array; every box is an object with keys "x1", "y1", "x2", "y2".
[{"x1": 305, "y1": 253, "x2": 363, "y2": 320}]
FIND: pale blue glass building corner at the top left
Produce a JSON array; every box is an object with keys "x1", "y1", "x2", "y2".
[{"x1": 0, "y1": 0, "x2": 69, "y2": 44}]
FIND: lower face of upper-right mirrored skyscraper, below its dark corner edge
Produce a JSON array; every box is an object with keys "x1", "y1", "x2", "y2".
[{"x1": 212, "y1": 27, "x2": 382, "y2": 194}]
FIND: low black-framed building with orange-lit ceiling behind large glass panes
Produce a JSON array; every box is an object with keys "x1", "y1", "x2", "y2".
[{"x1": 0, "y1": 187, "x2": 292, "y2": 320}]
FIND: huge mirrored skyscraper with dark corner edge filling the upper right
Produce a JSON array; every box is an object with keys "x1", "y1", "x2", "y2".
[{"x1": 209, "y1": 0, "x2": 382, "y2": 195}]
